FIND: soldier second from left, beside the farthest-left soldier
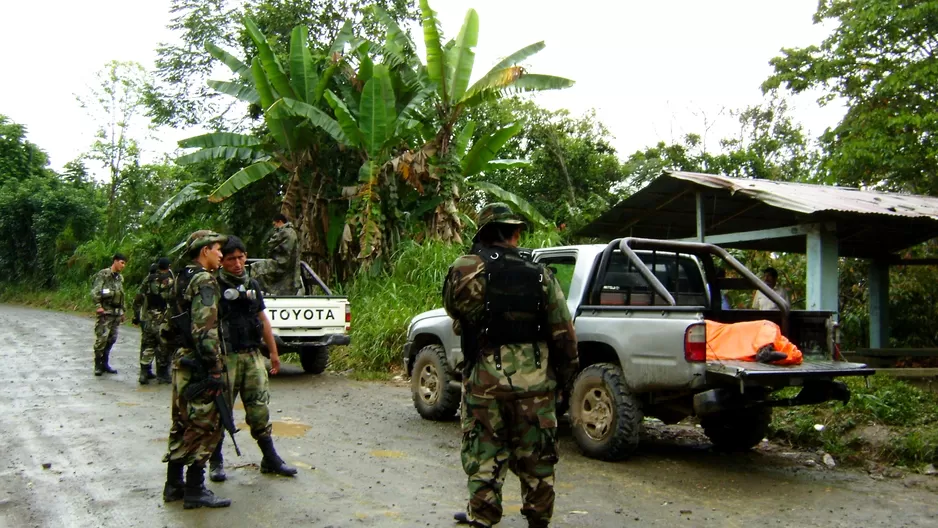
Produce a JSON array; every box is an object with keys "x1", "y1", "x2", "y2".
[{"x1": 134, "y1": 257, "x2": 172, "y2": 385}]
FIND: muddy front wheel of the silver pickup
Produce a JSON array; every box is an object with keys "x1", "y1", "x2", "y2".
[{"x1": 410, "y1": 345, "x2": 461, "y2": 421}]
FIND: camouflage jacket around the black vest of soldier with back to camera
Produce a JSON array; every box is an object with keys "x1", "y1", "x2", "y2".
[{"x1": 443, "y1": 243, "x2": 579, "y2": 398}]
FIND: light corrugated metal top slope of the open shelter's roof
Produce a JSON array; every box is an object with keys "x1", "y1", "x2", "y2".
[{"x1": 663, "y1": 171, "x2": 938, "y2": 220}]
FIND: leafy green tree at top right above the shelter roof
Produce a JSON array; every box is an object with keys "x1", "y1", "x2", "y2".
[{"x1": 762, "y1": 0, "x2": 938, "y2": 194}]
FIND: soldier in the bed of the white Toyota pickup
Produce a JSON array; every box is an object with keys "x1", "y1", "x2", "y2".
[{"x1": 252, "y1": 214, "x2": 303, "y2": 295}]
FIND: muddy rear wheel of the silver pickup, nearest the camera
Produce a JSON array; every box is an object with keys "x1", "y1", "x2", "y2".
[{"x1": 570, "y1": 363, "x2": 642, "y2": 460}]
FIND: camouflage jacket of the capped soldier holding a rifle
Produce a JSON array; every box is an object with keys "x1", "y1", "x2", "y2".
[{"x1": 180, "y1": 265, "x2": 222, "y2": 372}]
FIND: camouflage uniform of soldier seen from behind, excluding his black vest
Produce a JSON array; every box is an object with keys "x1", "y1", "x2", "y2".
[{"x1": 443, "y1": 204, "x2": 578, "y2": 526}]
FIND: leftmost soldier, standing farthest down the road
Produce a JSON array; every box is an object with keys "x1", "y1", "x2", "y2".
[{"x1": 91, "y1": 253, "x2": 127, "y2": 376}]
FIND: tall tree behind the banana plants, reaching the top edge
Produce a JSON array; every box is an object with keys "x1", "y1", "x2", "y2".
[{"x1": 148, "y1": 0, "x2": 416, "y2": 127}]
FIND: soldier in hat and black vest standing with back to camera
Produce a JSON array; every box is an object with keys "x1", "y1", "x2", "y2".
[{"x1": 443, "y1": 203, "x2": 578, "y2": 527}]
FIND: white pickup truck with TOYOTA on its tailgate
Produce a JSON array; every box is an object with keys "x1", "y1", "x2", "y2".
[{"x1": 252, "y1": 262, "x2": 352, "y2": 374}]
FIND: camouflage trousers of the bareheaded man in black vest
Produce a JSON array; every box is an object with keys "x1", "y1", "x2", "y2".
[{"x1": 226, "y1": 348, "x2": 271, "y2": 440}]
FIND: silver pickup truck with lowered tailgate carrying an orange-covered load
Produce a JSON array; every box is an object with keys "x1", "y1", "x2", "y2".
[{"x1": 403, "y1": 238, "x2": 873, "y2": 460}]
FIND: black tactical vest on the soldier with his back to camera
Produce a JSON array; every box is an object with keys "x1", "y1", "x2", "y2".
[{"x1": 478, "y1": 247, "x2": 547, "y2": 368}]
